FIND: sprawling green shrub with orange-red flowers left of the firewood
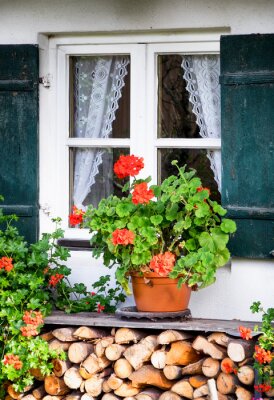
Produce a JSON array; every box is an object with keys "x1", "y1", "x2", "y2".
[{"x1": 0, "y1": 203, "x2": 124, "y2": 399}]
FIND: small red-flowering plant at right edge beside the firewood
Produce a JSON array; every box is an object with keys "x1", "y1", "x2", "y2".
[{"x1": 239, "y1": 301, "x2": 274, "y2": 393}]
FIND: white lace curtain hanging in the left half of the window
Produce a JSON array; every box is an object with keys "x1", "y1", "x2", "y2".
[{"x1": 73, "y1": 56, "x2": 129, "y2": 209}]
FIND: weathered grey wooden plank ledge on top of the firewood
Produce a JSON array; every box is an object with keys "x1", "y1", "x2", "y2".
[{"x1": 45, "y1": 311, "x2": 257, "y2": 337}]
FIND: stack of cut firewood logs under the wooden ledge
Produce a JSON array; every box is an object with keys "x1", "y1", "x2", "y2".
[{"x1": 6, "y1": 326, "x2": 274, "y2": 400}]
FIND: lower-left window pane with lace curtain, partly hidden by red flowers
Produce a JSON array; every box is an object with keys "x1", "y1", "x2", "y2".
[{"x1": 70, "y1": 148, "x2": 129, "y2": 208}]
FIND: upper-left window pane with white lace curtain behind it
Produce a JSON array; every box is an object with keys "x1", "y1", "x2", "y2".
[{"x1": 70, "y1": 55, "x2": 130, "y2": 138}]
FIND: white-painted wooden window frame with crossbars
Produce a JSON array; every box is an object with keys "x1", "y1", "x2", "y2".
[{"x1": 40, "y1": 31, "x2": 224, "y2": 238}]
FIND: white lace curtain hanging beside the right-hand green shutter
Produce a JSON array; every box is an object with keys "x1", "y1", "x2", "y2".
[{"x1": 182, "y1": 55, "x2": 221, "y2": 191}]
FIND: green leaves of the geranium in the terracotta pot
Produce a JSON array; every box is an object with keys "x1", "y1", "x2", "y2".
[{"x1": 83, "y1": 161, "x2": 236, "y2": 293}]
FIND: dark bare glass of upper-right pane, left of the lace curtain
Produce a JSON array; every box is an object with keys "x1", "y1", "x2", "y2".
[{"x1": 157, "y1": 54, "x2": 200, "y2": 138}]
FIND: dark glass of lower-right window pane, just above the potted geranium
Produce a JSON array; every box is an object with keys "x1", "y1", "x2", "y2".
[{"x1": 158, "y1": 149, "x2": 221, "y2": 202}]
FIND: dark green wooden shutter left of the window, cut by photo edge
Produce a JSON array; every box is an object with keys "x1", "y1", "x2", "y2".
[{"x1": 0, "y1": 45, "x2": 39, "y2": 242}]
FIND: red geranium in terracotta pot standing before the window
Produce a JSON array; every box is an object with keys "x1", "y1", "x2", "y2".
[{"x1": 78, "y1": 155, "x2": 236, "y2": 311}]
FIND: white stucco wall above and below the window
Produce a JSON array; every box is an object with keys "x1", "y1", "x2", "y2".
[{"x1": 0, "y1": 0, "x2": 274, "y2": 320}]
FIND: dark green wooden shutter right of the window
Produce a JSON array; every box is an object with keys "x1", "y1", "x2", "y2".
[{"x1": 220, "y1": 34, "x2": 274, "y2": 258}]
